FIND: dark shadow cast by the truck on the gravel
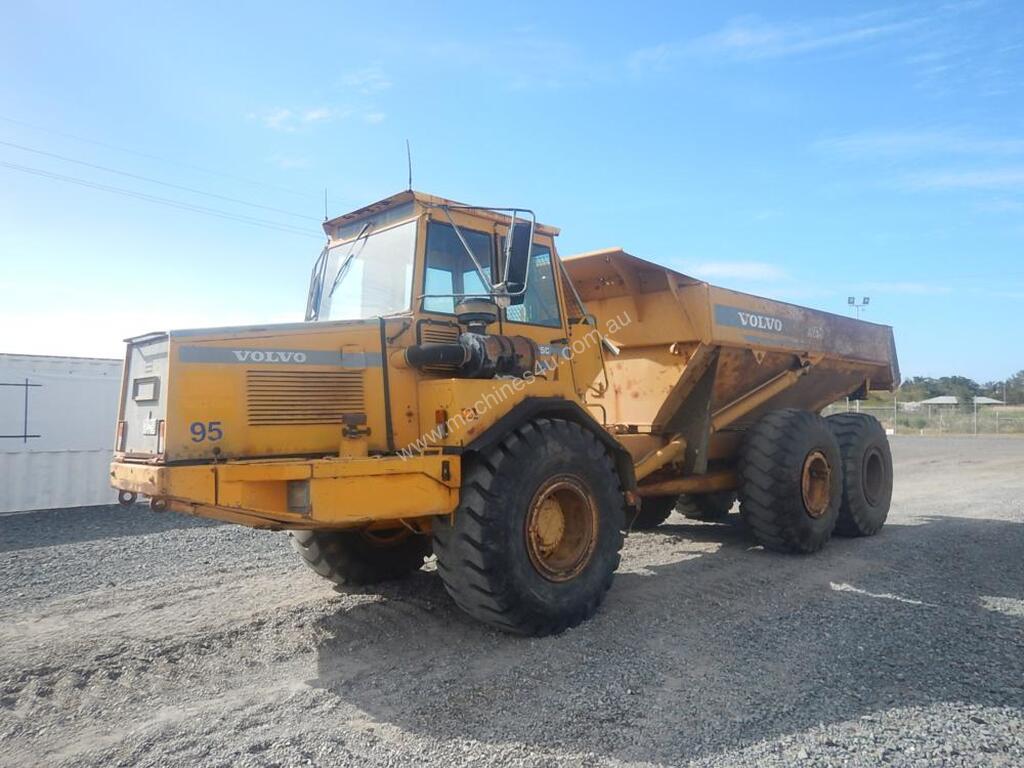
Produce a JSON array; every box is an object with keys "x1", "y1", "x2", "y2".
[{"x1": 311, "y1": 517, "x2": 1024, "y2": 762}]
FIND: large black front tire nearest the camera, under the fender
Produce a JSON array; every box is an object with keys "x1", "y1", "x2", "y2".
[{"x1": 433, "y1": 418, "x2": 625, "y2": 636}]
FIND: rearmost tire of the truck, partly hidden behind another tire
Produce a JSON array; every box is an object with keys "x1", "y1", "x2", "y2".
[{"x1": 825, "y1": 414, "x2": 893, "y2": 536}]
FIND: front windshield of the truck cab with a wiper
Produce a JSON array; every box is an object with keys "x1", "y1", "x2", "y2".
[{"x1": 316, "y1": 219, "x2": 416, "y2": 321}]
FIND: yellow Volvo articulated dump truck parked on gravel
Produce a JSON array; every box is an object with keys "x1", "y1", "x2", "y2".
[{"x1": 111, "y1": 190, "x2": 899, "y2": 635}]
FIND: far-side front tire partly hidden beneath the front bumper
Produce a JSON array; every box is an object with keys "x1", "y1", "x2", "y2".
[{"x1": 288, "y1": 528, "x2": 430, "y2": 586}]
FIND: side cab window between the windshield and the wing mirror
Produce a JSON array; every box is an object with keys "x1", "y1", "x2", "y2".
[{"x1": 423, "y1": 221, "x2": 492, "y2": 314}]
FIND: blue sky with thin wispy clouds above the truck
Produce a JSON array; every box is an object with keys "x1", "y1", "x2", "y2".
[{"x1": 0, "y1": 0, "x2": 1024, "y2": 380}]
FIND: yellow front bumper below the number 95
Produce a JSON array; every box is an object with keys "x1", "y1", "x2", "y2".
[{"x1": 111, "y1": 455, "x2": 461, "y2": 528}]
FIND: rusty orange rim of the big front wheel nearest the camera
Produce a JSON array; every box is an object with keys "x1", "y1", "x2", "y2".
[{"x1": 525, "y1": 475, "x2": 598, "y2": 582}]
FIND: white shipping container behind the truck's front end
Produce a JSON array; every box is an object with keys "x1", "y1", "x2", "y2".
[{"x1": 0, "y1": 354, "x2": 123, "y2": 513}]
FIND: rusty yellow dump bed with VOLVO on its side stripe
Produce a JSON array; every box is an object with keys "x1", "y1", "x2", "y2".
[{"x1": 564, "y1": 249, "x2": 899, "y2": 444}]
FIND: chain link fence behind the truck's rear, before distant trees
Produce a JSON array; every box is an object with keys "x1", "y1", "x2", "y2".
[{"x1": 821, "y1": 400, "x2": 1024, "y2": 435}]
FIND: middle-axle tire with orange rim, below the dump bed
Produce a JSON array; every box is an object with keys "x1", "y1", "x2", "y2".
[{"x1": 739, "y1": 409, "x2": 843, "y2": 553}]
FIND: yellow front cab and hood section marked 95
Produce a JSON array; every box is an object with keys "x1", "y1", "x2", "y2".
[{"x1": 112, "y1": 190, "x2": 603, "y2": 528}]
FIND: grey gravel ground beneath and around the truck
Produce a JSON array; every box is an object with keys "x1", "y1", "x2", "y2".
[{"x1": 0, "y1": 438, "x2": 1024, "y2": 766}]
